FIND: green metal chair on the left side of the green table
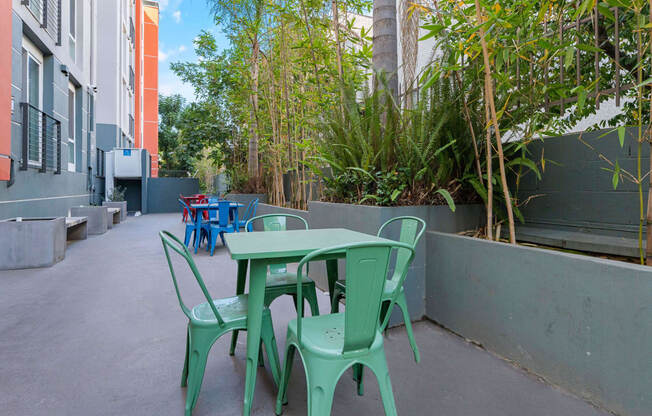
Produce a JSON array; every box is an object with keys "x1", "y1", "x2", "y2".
[{"x1": 159, "y1": 231, "x2": 280, "y2": 416}]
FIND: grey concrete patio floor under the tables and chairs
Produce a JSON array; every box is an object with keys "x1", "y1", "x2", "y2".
[{"x1": 0, "y1": 214, "x2": 608, "y2": 416}]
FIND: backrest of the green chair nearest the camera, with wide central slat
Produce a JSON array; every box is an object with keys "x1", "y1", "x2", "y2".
[{"x1": 297, "y1": 241, "x2": 414, "y2": 354}]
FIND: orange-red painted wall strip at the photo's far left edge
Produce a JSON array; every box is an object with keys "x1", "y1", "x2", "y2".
[{"x1": 0, "y1": 0, "x2": 12, "y2": 181}]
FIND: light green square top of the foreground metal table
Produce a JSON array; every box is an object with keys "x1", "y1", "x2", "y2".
[{"x1": 224, "y1": 228, "x2": 389, "y2": 260}]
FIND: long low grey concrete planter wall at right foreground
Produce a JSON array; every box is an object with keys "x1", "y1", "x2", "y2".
[{"x1": 426, "y1": 232, "x2": 652, "y2": 416}]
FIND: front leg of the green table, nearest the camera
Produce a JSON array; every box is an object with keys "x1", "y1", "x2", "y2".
[{"x1": 242, "y1": 260, "x2": 267, "y2": 416}]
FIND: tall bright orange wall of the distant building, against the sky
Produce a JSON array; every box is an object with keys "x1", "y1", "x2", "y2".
[{"x1": 143, "y1": 5, "x2": 159, "y2": 177}]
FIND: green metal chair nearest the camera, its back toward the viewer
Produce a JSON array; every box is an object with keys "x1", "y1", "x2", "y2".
[{"x1": 276, "y1": 242, "x2": 414, "y2": 416}]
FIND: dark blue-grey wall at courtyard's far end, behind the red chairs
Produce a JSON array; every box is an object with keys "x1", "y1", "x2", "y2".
[{"x1": 147, "y1": 178, "x2": 199, "y2": 214}]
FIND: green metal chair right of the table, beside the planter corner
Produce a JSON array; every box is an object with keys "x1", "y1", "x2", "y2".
[{"x1": 331, "y1": 216, "x2": 426, "y2": 363}]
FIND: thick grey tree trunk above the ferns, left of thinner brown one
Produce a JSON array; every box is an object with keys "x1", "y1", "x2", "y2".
[{"x1": 372, "y1": 0, "x2": 398, "y2": 103}]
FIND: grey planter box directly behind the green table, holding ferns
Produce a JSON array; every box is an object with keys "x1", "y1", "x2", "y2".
[{"x1": 308, "y1": 201, "x2": 484, "y2": 325}]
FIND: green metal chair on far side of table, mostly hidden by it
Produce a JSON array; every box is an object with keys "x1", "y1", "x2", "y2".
[{"x1": 230, "y1": 214, "x2": 319, "y2": 358}]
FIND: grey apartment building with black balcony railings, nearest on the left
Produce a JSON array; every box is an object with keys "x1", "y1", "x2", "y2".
[{"x1": 0, "y1": 0, "x2": 103, "y2": 219}]
